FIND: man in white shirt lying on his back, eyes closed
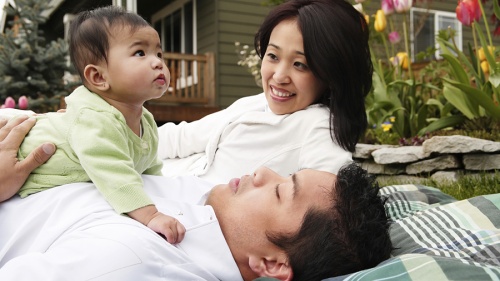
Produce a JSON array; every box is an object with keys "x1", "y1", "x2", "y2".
[{"x1": 0, "y1": 116, "x2": 391, "y2": 280}]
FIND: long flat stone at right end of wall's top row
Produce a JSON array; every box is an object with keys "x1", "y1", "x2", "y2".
[{"x1": 422, "y1": 135, "x2": 500, "y2": 154}]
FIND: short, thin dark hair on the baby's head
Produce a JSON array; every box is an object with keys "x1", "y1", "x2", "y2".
[{"x1": 69, "y1": 6, "x2": 150, "y2": 81}]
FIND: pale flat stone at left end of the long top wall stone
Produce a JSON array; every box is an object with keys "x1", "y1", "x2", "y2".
[{"x1": 372, "y1": 146, "x2": 429, "y2": 164}]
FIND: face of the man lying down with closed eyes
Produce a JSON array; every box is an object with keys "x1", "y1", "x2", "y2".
[{"x1": 207, "y1": 168, "x2": 336, "y2": 262}]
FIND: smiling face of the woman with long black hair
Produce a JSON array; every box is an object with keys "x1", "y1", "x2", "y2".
[{"x1": 261, "y1": 20, "x2": 324, "y2": 114}]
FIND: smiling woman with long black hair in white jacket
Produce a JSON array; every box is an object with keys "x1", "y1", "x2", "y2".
[{"x1": 159, "y1": 0, "x2": 373, "y2": 182}]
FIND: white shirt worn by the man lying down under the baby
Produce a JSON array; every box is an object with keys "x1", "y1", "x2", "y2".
[{"x1": 0, "y1": 176, "x2": 242, "y2": 281}]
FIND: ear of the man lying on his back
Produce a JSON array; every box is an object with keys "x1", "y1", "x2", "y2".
[{"x1": 248, "y1": 254, "x2": 293, "y2": 281}]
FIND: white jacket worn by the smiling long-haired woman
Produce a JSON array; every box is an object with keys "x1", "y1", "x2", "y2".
[{"x1": 158, "y1": 94, "x2": 352, "y2": 183}]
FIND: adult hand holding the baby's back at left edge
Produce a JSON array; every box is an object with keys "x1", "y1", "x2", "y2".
[{"x1": 0, "y1": 116, "x2": 56, "y2": 202}]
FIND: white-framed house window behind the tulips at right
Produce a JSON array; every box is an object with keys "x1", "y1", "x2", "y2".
[{"x1": 410, "y1": 8, "x2": 462, "y2": 59}]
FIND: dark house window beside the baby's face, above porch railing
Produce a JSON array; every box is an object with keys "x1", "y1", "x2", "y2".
[{"x1": 151, "y1": 0, "x2": 197, "y2": 54}]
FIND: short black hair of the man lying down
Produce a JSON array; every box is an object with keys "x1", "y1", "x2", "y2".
[{"x1": 267, "y1": 162, "x2": 393, "y2": 280}]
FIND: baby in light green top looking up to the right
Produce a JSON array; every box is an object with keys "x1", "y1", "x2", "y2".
[{"x1": 2, "y1": 6, "x2": 185, "y2": 243}]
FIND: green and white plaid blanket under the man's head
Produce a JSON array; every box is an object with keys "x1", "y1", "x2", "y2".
[{"x1": 326, "y1": 185, "x2": 500, "y2": 281}]
